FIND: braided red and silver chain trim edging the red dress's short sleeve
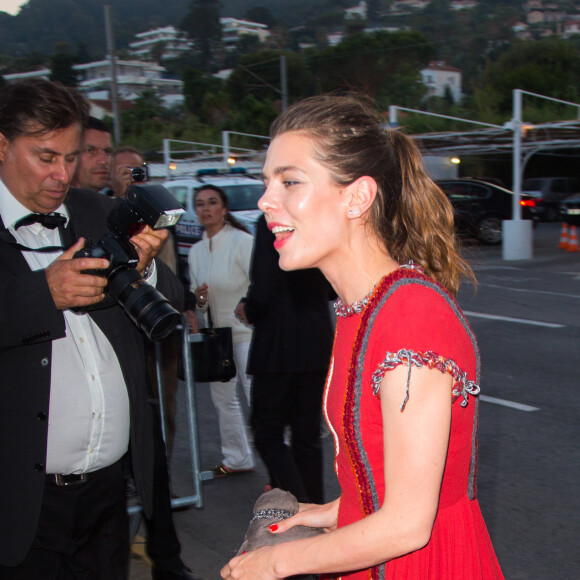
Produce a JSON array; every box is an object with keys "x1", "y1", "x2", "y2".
[{"x1": 372, "y1": 349, "x2": 480, "y2": 411}]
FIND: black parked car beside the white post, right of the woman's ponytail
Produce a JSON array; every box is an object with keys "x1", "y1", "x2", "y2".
[{"x1": 437, "y1": 179, "x2": 535, "y2": 244}]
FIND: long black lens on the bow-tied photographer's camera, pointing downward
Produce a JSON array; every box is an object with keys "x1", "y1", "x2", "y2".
[{"x1": 107, "y1": 268, "x2": 181, "y2": 340}]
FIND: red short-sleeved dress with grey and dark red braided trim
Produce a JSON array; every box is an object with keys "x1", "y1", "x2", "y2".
[{"x1": 324, "y1": 265, "x2": 503, "y2": 580}]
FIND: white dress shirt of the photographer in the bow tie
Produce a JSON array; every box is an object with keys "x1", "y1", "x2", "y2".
[{"x1": 0, "y1": 181, "x2": 129, "y2": 474}]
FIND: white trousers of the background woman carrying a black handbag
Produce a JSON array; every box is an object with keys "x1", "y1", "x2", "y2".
[{"x1": 209, "y1": 341, "x2": 254, "y2": 469}]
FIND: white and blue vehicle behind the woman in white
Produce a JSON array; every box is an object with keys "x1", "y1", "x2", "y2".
[{"x1": 163, "y1": 169, "x2": 264, "y2": 270}]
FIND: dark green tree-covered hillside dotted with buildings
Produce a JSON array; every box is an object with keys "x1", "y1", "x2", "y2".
[{"x1": 0, "y1": 0, "x2": 580, "y2": 178}]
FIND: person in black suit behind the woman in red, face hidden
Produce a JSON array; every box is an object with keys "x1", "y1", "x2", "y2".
[{"x1": 236, "y1": 216, "x2": 333, "y2": 503}]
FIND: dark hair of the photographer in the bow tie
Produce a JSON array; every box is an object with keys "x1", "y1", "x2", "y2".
[{"x1": 0, "y1": 79, "x2": 89, "y2": 139}]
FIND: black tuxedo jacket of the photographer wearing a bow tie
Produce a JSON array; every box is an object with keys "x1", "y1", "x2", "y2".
[{"x1": 0, "y1": 189, "x2": 183, "y2": 566}]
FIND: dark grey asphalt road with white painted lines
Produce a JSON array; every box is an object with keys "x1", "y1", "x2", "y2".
[{"x1": 131, "y1": 224, "x2": 580, "y2": 580}]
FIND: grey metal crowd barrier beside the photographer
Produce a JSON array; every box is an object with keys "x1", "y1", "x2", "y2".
[{"x1": 127, "y1": 316, "x2": 214, "y2": 538}]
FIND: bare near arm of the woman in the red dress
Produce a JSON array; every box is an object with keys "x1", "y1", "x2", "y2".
[{"x1": 222, "y1": 367, "x2": 452, "y2": 580}]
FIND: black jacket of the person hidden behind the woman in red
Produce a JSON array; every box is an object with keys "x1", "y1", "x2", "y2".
[{"x1": 245, "y1": 216, "x2": 335, "y2": 375}]
